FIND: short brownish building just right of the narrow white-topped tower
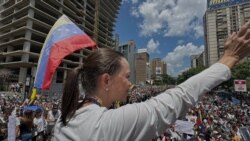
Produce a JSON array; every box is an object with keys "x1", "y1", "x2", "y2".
[{"x1": 150, "y1": 58, "x2": 167, "y2": 80}]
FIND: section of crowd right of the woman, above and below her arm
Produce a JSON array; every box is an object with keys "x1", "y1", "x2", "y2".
[{"x1": 129, "y1": 86, "x2": 250, "y2": 141}]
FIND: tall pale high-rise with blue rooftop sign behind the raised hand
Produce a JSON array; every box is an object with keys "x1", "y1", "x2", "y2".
[{"x1": 204, "y1": 0, "x2": 250, "y2": 66}]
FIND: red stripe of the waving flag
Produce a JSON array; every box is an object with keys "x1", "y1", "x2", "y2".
[{"x1": 42, "y1": 34, "x2": 96, "y2": 89}]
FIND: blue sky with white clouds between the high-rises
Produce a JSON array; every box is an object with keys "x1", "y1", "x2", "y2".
[{"x1": 114, "y1": 0, "x2": 207, "y2": 77}]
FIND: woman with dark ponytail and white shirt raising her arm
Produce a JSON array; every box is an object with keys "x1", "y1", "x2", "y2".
[{"x1": 55, "y1": 22, "x2": 250, "y2": 141}]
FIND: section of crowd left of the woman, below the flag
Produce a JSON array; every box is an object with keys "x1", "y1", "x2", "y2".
[{"x1": 0, "y1": 93, "x2": 61, "y2": 141}]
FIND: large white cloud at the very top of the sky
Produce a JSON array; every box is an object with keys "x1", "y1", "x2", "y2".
[{"x1": 131, "y1": 0, "x2": 206, "y2": 37}]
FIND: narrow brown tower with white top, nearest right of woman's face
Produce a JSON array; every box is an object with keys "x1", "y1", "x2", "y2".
[{"x1": 135, "y1": 49, "x2": 149, "y2": 85}]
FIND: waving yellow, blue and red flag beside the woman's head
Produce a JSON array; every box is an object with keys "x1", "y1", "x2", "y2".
[{"x1": 34, "y1": 15, "x2": 96, "y2": 90}]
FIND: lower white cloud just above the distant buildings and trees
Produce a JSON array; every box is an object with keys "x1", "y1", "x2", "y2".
[{"x1": 163, "y1": 43, "x2": 204, "y2": 76}]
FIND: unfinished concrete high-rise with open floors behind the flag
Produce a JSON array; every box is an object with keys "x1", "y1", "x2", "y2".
[{"x1": 0, "y1": 0, "x2": 121, "y2": 93}]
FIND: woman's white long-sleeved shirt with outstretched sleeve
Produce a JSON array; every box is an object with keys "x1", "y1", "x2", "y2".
[{"x1": 55, "y1": 63, "x2": 231, "y2": 141}]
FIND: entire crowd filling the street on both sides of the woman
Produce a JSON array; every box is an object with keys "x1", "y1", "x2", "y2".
[{"x1": 0, "y1": 86, "x2": 250, "y2": 141}]
